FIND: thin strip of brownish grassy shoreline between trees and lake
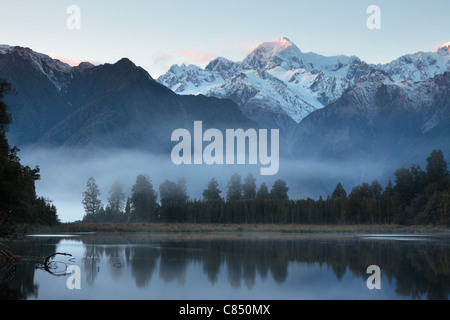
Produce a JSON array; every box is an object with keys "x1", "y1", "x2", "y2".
[{"x1": 27, "y1": 222, "x2": 450, "y2": 234}]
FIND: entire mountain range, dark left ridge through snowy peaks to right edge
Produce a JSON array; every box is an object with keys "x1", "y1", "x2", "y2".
[{"x1": 0, "y1": 38, "x2": 450, "y2": 196}]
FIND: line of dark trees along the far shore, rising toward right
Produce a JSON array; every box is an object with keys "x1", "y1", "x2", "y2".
[{"x1": 82, "y1": 150, "x2": 450, "y2": 226}]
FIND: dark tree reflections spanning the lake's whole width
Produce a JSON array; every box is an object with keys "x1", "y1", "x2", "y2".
[{"x1": 0, "y1": 239, "x2": 450, "y2": 299}]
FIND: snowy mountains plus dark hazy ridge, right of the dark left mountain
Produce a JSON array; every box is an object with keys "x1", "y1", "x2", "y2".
[{"x1": 157, "y1": 38, "x2": 450, "y2": 178}]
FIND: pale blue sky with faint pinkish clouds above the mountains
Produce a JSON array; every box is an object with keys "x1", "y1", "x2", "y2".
[{"x1": 0, "y1": 0, "x2": 450, "y2": 78}]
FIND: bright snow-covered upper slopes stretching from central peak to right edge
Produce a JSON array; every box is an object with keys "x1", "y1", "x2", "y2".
[{"x1": 157, "y1": 38, "x2": 450, "y2": 123}]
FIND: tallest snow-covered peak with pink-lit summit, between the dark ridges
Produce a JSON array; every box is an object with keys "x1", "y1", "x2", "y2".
[{"x1": 157, "y1": 38, "x2": 368, "y2": 136}]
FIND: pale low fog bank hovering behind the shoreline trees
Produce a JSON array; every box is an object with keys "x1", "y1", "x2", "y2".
[{"x1": 19, "y1": 147, "x2": 392, "y2": 222}]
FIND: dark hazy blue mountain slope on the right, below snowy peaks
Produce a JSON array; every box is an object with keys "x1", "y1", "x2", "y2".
[{"x1": 294, "y1": 70, "x2": 450, "y2": 172}]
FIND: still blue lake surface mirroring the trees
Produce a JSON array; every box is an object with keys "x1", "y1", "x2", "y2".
[{"x1": 0, "y1": 234, "x2": 450, "y2": 300}]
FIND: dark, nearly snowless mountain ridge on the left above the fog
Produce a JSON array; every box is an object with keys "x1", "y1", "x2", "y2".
[{"x1": 0, "y1": 46, "x2": 256, "y2": 151}]
